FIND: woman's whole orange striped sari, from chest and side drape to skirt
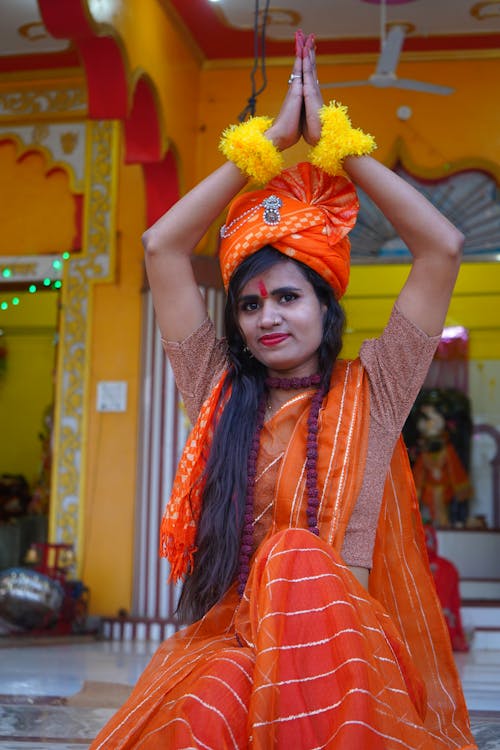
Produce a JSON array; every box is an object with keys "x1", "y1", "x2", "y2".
[{"x1": 92, "y1": 361, "x2": 475, "y2": 750}]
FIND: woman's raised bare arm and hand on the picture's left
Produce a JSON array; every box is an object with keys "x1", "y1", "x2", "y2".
[{"x1": 143, "y1": 42, "x2": 302, "y2": 341}]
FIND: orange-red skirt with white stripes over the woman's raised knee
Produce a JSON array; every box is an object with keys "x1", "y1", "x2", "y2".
[{"x1": 91, "y1": 529, "x2": 475, "y2": 750}]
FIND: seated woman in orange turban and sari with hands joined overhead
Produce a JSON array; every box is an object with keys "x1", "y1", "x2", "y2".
[{"x1": 92, "y1": 32, "x2": 475, "y2": 750}]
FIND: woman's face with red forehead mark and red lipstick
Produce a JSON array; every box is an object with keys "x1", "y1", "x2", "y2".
[{"x1": 237, "y1": 260, "x2": 325, "y2": 377}]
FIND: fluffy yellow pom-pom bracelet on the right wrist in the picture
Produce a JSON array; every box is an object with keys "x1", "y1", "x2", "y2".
[{"x1": 309, "y1": 101, "x2": 377, "y2": 175}]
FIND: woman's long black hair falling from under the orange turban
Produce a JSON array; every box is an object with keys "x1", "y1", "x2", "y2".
[{"x1": 177, "y1": 245, "x2": 345, "y2": 622}]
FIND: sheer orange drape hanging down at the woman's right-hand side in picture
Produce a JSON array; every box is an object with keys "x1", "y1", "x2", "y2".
[{"x1": 370, "y1": 438, "x2": 476, "y2": 748}]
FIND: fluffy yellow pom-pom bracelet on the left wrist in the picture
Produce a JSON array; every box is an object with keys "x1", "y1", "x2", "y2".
[{"x1": 219, "y1": 117, "x2": 283, "y2": 184}]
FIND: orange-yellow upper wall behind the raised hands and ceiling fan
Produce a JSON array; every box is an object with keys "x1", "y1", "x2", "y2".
[{"x1": 200, "y1": 55, "x2": 500, "y2": 178}]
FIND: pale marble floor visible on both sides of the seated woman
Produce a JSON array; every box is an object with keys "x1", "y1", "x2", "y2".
[{"x1": 0, "y1": 638, "x2": 500, "y2": 750}]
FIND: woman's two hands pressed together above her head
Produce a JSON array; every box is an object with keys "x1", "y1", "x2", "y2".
[{"x1": 266, "y1": 29, "x2": 323, "y2": 151}]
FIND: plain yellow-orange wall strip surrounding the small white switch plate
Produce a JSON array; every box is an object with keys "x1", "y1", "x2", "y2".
[{"x1": 81, "y1": 159, "x2": 145, "y2": 614}]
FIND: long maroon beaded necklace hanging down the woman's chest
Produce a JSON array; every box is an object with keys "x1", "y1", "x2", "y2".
[{"x1": 238, "y1": 375, "x2": 325, "y2": 597}]
